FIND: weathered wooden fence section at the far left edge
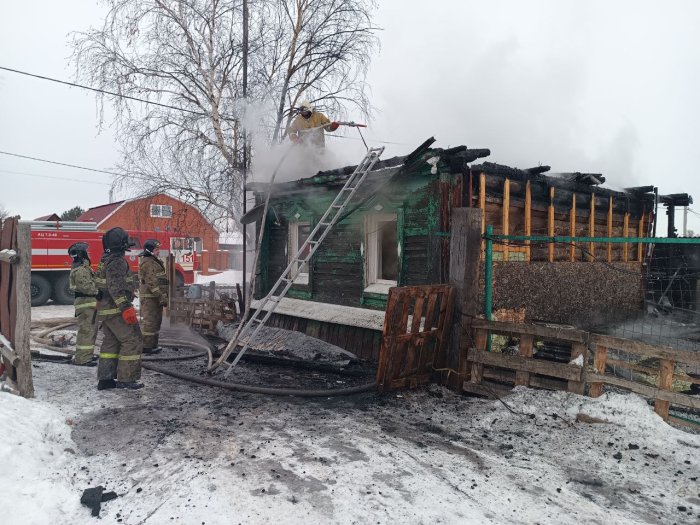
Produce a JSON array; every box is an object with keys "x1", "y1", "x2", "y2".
[{"x1": 0, "y1": 218, "x2": 34, "y2": 397}]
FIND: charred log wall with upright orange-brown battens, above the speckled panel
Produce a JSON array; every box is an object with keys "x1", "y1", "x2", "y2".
[{"x1": 472, "y1": 173, "x2": 649, "y2": 262}]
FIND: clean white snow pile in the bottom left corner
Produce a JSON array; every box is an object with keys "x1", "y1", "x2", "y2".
[{"x1": 0, "y1": 394, "x2": 90, "y2": 525}]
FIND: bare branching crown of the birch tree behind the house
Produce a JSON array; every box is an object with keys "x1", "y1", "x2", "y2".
[{"x1": 72, "y1": 0, "x2": 378, "y2": 220}]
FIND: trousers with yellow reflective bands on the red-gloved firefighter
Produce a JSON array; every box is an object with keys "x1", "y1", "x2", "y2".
[{"x1": 97, "y1": 315, "x2": 143, "y2": 382}]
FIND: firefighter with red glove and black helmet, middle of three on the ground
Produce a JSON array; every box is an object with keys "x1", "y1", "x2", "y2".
[{"x1": 95, "y1": 228, "x2": 143, "y2": 390}]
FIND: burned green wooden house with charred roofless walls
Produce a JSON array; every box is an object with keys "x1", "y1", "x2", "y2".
[{"x1": 248, "y1": 139, "x2": 680, "y2": 358}]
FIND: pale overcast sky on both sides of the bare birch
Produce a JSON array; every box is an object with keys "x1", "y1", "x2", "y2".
[{"x1": 0, "y1": 0, "x2": 700, "y2": 231}]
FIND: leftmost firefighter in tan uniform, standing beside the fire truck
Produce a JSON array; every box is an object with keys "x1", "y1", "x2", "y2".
[{"x1": 68, "y1": 242, "x2": 100, "y2": 366}]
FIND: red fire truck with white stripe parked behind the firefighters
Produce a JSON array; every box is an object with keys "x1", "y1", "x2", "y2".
[{"x1": 31, "y1": 221, "x2": 197, "y2": 306}]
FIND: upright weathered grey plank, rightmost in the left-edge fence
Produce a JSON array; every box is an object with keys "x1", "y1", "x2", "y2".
[{"x1": 13, "y1": 224, "x2": 34, "y2": 397}]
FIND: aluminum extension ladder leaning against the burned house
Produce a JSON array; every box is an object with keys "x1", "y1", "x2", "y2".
[{"x1": 224, "y1": 147, "x2": 384, "y2": 377}]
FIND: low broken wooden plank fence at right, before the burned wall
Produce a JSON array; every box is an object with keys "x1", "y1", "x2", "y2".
[{"x1": 463, "y1": 319, "x2": 700, "y2": 423}]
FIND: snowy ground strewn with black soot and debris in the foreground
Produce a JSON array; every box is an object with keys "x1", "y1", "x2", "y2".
[{"x1": 0, "y1": 307, "x2": 700, "y2": 525}]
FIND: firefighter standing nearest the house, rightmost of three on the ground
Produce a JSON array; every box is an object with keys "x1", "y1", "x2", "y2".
[{"x1": 139, "y1": 239, "x2": 169, "y2": 354}]
